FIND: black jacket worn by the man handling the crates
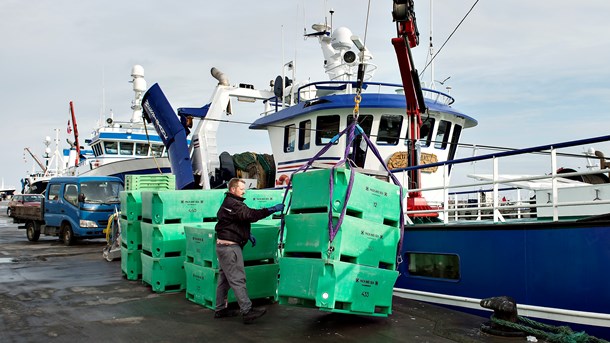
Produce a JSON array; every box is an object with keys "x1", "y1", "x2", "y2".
[{"x1": 216, "y1": 192, "x2": 271, "y2": 248}]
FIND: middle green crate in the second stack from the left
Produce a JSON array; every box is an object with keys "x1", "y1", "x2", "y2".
[{"x1": 140, "y1": 222, "x2": 207, "y2": 257}]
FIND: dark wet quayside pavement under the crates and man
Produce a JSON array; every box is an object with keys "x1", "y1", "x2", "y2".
[{"x1": 0, "y1": 204, "x2": 526, "y2": 343}]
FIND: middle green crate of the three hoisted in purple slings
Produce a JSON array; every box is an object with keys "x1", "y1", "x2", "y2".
[{"x1": 283, "y1": 213, "x2": 400, "y2": 270}]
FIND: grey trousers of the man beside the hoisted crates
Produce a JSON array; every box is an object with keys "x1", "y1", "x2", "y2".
[{"x1": 216, "y1": 244, "x2": 252, "y2": 313}]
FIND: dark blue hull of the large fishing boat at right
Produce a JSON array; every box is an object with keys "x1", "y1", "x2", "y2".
[{"x1": 396, "y1": 221, "x2": 610, "y2": 337}]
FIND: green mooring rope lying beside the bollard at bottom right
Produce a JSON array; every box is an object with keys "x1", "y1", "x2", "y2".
[{"x1": 490, "y1": 314, "x2": 609, "y2": 343}]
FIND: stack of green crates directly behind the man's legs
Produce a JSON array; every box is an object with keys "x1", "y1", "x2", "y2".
[{"x1": 184, "y1": 222, "x2": 279, "y2": 309}]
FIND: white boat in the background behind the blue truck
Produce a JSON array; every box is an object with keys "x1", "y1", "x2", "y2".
[{"x1": 22, "y1": 65, "x2": 171, "y2": 193}]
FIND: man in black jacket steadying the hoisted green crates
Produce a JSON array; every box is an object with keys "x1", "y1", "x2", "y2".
[{"x1": 214, "y1": 178, "x2": 284, "y2": 324}]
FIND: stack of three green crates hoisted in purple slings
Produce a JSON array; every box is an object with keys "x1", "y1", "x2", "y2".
[{"x1": 278, "y1": 168, "x2": 400, "y2": 316}]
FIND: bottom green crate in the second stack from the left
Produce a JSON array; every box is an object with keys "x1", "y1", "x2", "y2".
[{"x1": 141, "y1": 251, "x2": 186, "y2": 293}]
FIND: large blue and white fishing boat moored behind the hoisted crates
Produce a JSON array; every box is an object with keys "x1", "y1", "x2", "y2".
[{"x1": 138, "y1": 2, "x2": 610, "y2": 337}]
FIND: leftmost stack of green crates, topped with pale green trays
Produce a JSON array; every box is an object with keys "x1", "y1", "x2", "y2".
[{"x1": 119, "y1": 174, "x2": 176, "y2": 280}]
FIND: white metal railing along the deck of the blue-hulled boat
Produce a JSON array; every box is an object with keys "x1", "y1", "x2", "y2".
[{"x1": 392, "y1": 136, "x2": 610, "y2": 223}]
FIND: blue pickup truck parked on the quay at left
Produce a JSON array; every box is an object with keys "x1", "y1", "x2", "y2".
[{"x1": 12, "y1": 176, "x2": 123, "y2": 245}]
